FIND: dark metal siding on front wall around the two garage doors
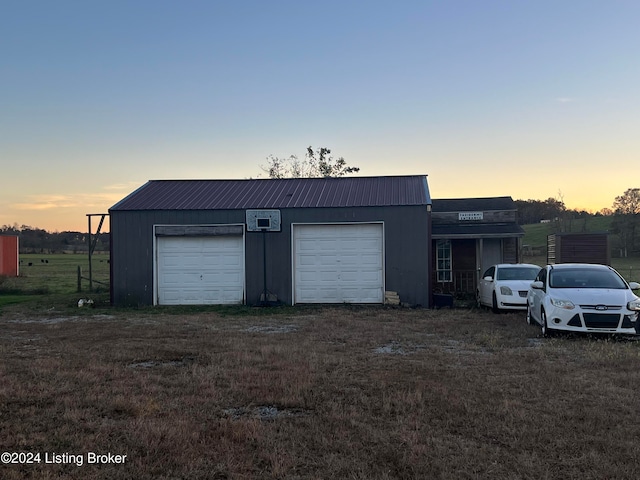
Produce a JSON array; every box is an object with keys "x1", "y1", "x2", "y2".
[{"x1": 110, "y1": 206, "x2": 431, "y2": 306}]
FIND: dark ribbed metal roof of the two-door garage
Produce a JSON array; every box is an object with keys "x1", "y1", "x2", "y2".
[{"x1": 110, "y1": 175, "x2": 431, "y2": 211}]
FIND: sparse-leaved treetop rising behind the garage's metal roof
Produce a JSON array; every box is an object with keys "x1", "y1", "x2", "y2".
[{"x1": 260, "y1": 147, "x2": 360, "y2": 178}]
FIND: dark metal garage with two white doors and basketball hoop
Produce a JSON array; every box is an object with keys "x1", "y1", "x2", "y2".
[{"x1": 109, "y1": 175, "x2": 431, "y2": 306}]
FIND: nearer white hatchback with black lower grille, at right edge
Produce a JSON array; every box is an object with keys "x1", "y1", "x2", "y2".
[{"x1": 527, "y1": 263, "x2": 640, "y2": 336}]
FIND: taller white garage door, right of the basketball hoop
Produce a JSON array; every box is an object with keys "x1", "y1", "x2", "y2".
[{"x1": 293, "y1": 224, "x2": 384, "y2": 303}]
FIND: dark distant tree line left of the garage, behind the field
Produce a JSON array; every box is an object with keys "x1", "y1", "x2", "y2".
[{"x1": 0, "y1": 224, "x2": 109, "y2": 253}]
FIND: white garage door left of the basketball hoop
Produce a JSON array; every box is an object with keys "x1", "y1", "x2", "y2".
[{"x1": 157, "y1": 236, "x2": 244, "y2": 305}]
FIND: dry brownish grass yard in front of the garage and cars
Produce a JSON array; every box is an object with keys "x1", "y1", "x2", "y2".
[{"x1": 0, "y1": 307, "x2": 640, "y2": 479}]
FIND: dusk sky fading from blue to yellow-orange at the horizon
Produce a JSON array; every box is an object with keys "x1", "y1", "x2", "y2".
[{"x1": 0, "y1": 0, "x2": 640, "y2": 231}]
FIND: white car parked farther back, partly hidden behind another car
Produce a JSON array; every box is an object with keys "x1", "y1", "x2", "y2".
[{"x1": 477, "y1": 263, "x2": 542, "y2": 312}]
